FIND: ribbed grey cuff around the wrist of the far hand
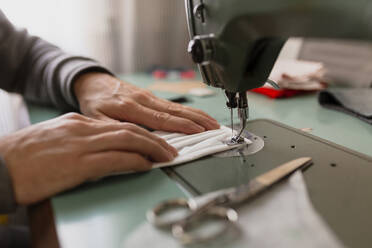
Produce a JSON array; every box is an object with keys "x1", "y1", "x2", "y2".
[{"x1": 60, "y1": 58, "x2": 113, "y2": 110}]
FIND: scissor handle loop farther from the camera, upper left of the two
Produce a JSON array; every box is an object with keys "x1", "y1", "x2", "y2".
[{"x1": 146, "y1": 198, "x2": 190, "y2": 228}]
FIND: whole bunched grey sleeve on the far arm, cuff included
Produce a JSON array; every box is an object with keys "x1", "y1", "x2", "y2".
[{"x1": 0, "y1": 10, "x2": 111, "y2": 110}]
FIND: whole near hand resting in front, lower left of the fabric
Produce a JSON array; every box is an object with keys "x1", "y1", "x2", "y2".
[{"x1": 0, "y1": 114, "x2": 177, "y2": 204}]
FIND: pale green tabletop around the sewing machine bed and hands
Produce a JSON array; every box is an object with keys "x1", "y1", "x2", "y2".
[{"x1": 29, "y1": 74, "x2": 372, "y2": 248}]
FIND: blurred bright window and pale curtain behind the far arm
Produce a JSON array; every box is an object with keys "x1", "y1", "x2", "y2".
[{"x1": 0, "y1": 0, "x2": 192, "y2": 73}]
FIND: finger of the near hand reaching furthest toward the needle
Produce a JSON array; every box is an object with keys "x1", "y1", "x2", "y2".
[{"x1": 87, "y1": 130, "x2": 174, "y2": 162}]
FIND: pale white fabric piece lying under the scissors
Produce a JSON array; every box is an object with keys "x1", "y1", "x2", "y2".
[{"x1": 121, "y1": 171, "x2": 344, "y2": 248}]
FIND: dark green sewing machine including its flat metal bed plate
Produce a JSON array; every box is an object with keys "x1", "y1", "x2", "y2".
[{"x1": 159, "y1": 0, "x2": 372, "y2": 247}]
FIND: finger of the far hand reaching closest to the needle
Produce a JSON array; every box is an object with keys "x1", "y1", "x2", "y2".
[{"x1": 142, "y1": 98, "x2": 220, "y2": 130}]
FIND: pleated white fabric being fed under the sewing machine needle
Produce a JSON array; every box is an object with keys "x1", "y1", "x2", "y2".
[{"x1": 153, "y1": 126, "x2": 252, "y2": 168}]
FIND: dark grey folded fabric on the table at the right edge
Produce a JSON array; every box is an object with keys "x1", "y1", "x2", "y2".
[{"x1": 318, "y1": 88, "x2": 372, "y2": 124}]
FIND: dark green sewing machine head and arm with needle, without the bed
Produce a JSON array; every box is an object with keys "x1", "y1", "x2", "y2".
[{"x1": 185, "y1": 0, "x2": 372, "y2": 142}]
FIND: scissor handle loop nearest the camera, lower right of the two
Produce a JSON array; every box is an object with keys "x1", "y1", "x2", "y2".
[{"x1": 172, "y1": 206, "x2": 238, "y2": 244}]
